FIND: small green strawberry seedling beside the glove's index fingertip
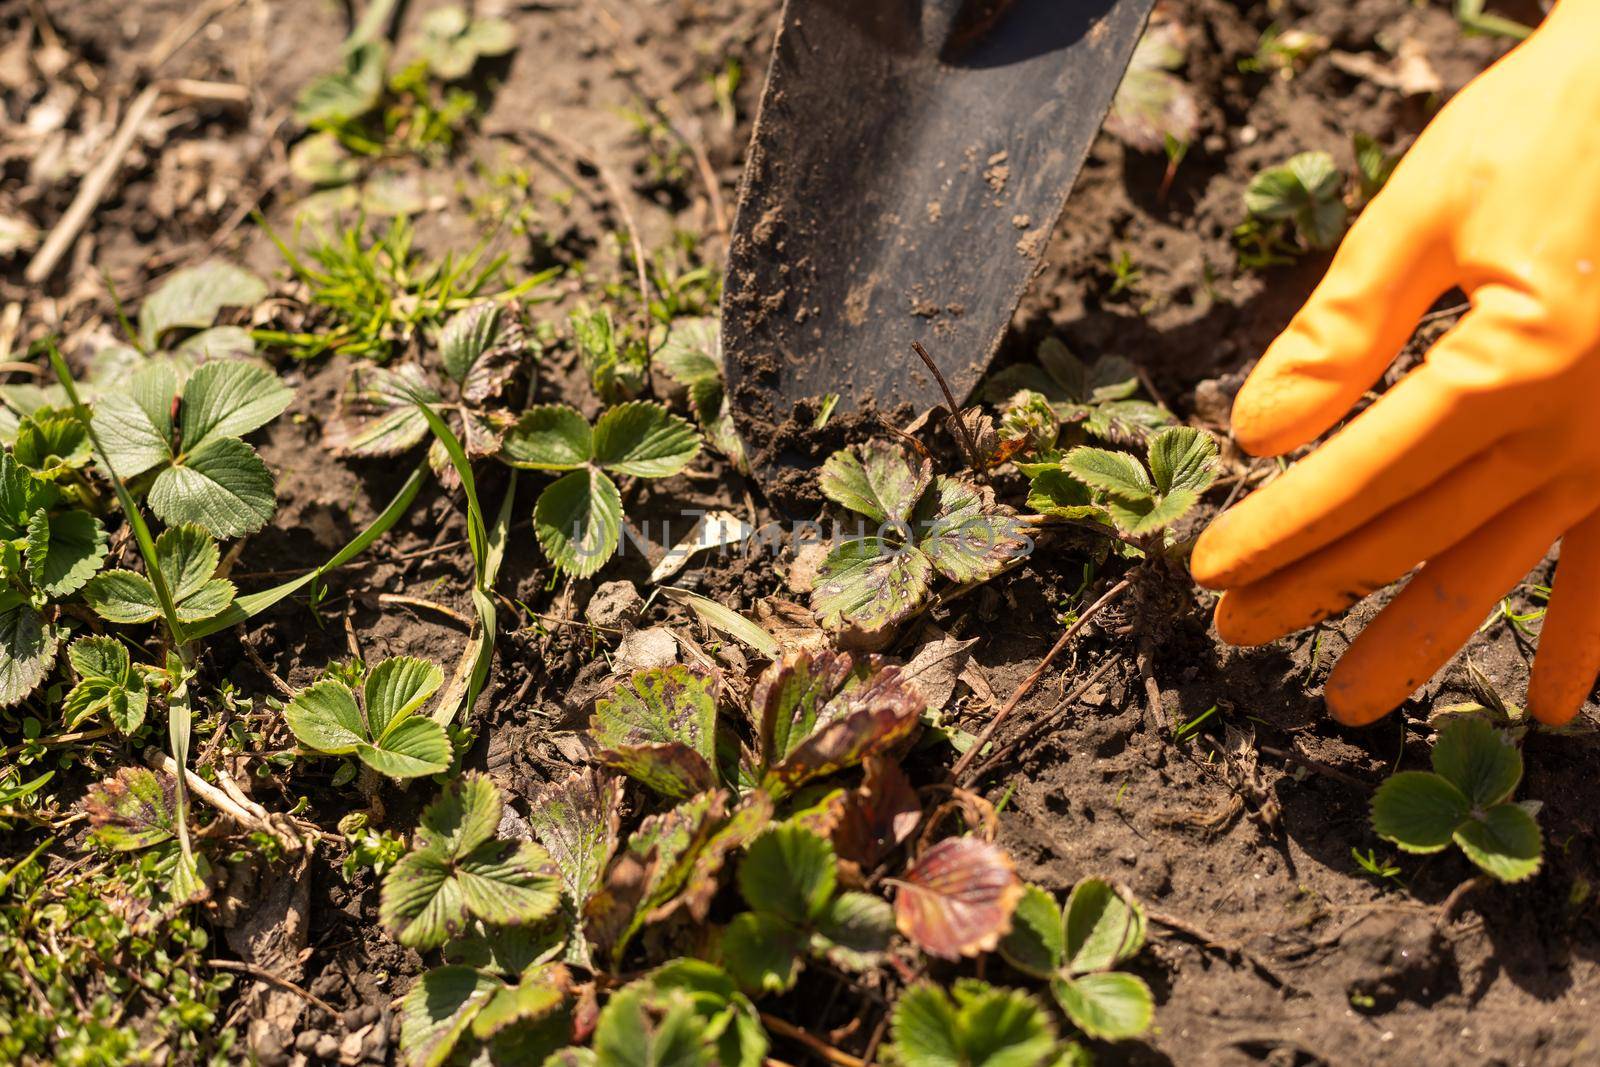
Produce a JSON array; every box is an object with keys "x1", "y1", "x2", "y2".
[{"x1": 1027, "y1": 426, "x2": 1218, "y2": 541}]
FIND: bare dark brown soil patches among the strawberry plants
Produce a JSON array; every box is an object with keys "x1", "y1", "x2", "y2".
[{"x1": 0, "y1": 0, "x2": 1600, "y2": 1067}]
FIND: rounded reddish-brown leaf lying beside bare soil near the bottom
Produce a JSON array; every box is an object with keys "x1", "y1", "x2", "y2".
[{"x1": 894, "y1": 837, "x2": 1022, "y2": 960}]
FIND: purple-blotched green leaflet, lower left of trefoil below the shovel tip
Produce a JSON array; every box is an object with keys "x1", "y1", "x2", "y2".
[{"x1": 811, "y1": 537, "x2": 934, "y2": 646}]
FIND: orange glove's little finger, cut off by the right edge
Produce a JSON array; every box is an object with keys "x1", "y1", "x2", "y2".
[{"x1": 1528, "y1": 512, "x2": 1600, "y2": 726}]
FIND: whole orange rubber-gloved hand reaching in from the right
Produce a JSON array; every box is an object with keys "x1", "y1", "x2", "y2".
[{"x1": 1192, "y1": 0, "x2": 1600, "y2": 725}]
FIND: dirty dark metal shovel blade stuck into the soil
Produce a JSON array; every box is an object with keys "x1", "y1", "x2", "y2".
[{"x1": 722, "y1": 0, "x2": 1152, "y2": 482}]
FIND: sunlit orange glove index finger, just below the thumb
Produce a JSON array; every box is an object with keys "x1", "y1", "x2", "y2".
[{"x1": 1189, "y1": 300, "x2": 1536, "y2": 589}]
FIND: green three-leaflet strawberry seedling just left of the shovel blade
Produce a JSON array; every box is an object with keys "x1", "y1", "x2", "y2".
[{"x1": 501, "y1": 400, "x2": 701, "y2": 577}]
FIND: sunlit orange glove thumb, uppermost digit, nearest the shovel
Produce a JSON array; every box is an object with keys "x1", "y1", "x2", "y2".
[{"x1": 1232, "y1": 159, "x2": 1454, "y2": 456}]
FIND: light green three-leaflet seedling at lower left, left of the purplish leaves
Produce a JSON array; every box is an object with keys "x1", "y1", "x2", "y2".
[{"x1": 378, "y1": 774, "x2": 562, "y2": 950}]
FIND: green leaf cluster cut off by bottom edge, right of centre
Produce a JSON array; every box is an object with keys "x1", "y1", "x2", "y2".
[{"x1": 890, "y1": 977, "x2": 1088, "y2": 1067}]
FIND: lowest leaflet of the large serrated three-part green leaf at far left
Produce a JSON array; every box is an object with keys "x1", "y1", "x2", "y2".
[{"x1": 148, "y1": 437, "x2": 278, "y2": 537}]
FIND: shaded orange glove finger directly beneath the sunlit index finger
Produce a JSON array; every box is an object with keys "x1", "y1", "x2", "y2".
[{"x1": 1216, "y1": 448, "x2": 1536, "y2": 645}]
